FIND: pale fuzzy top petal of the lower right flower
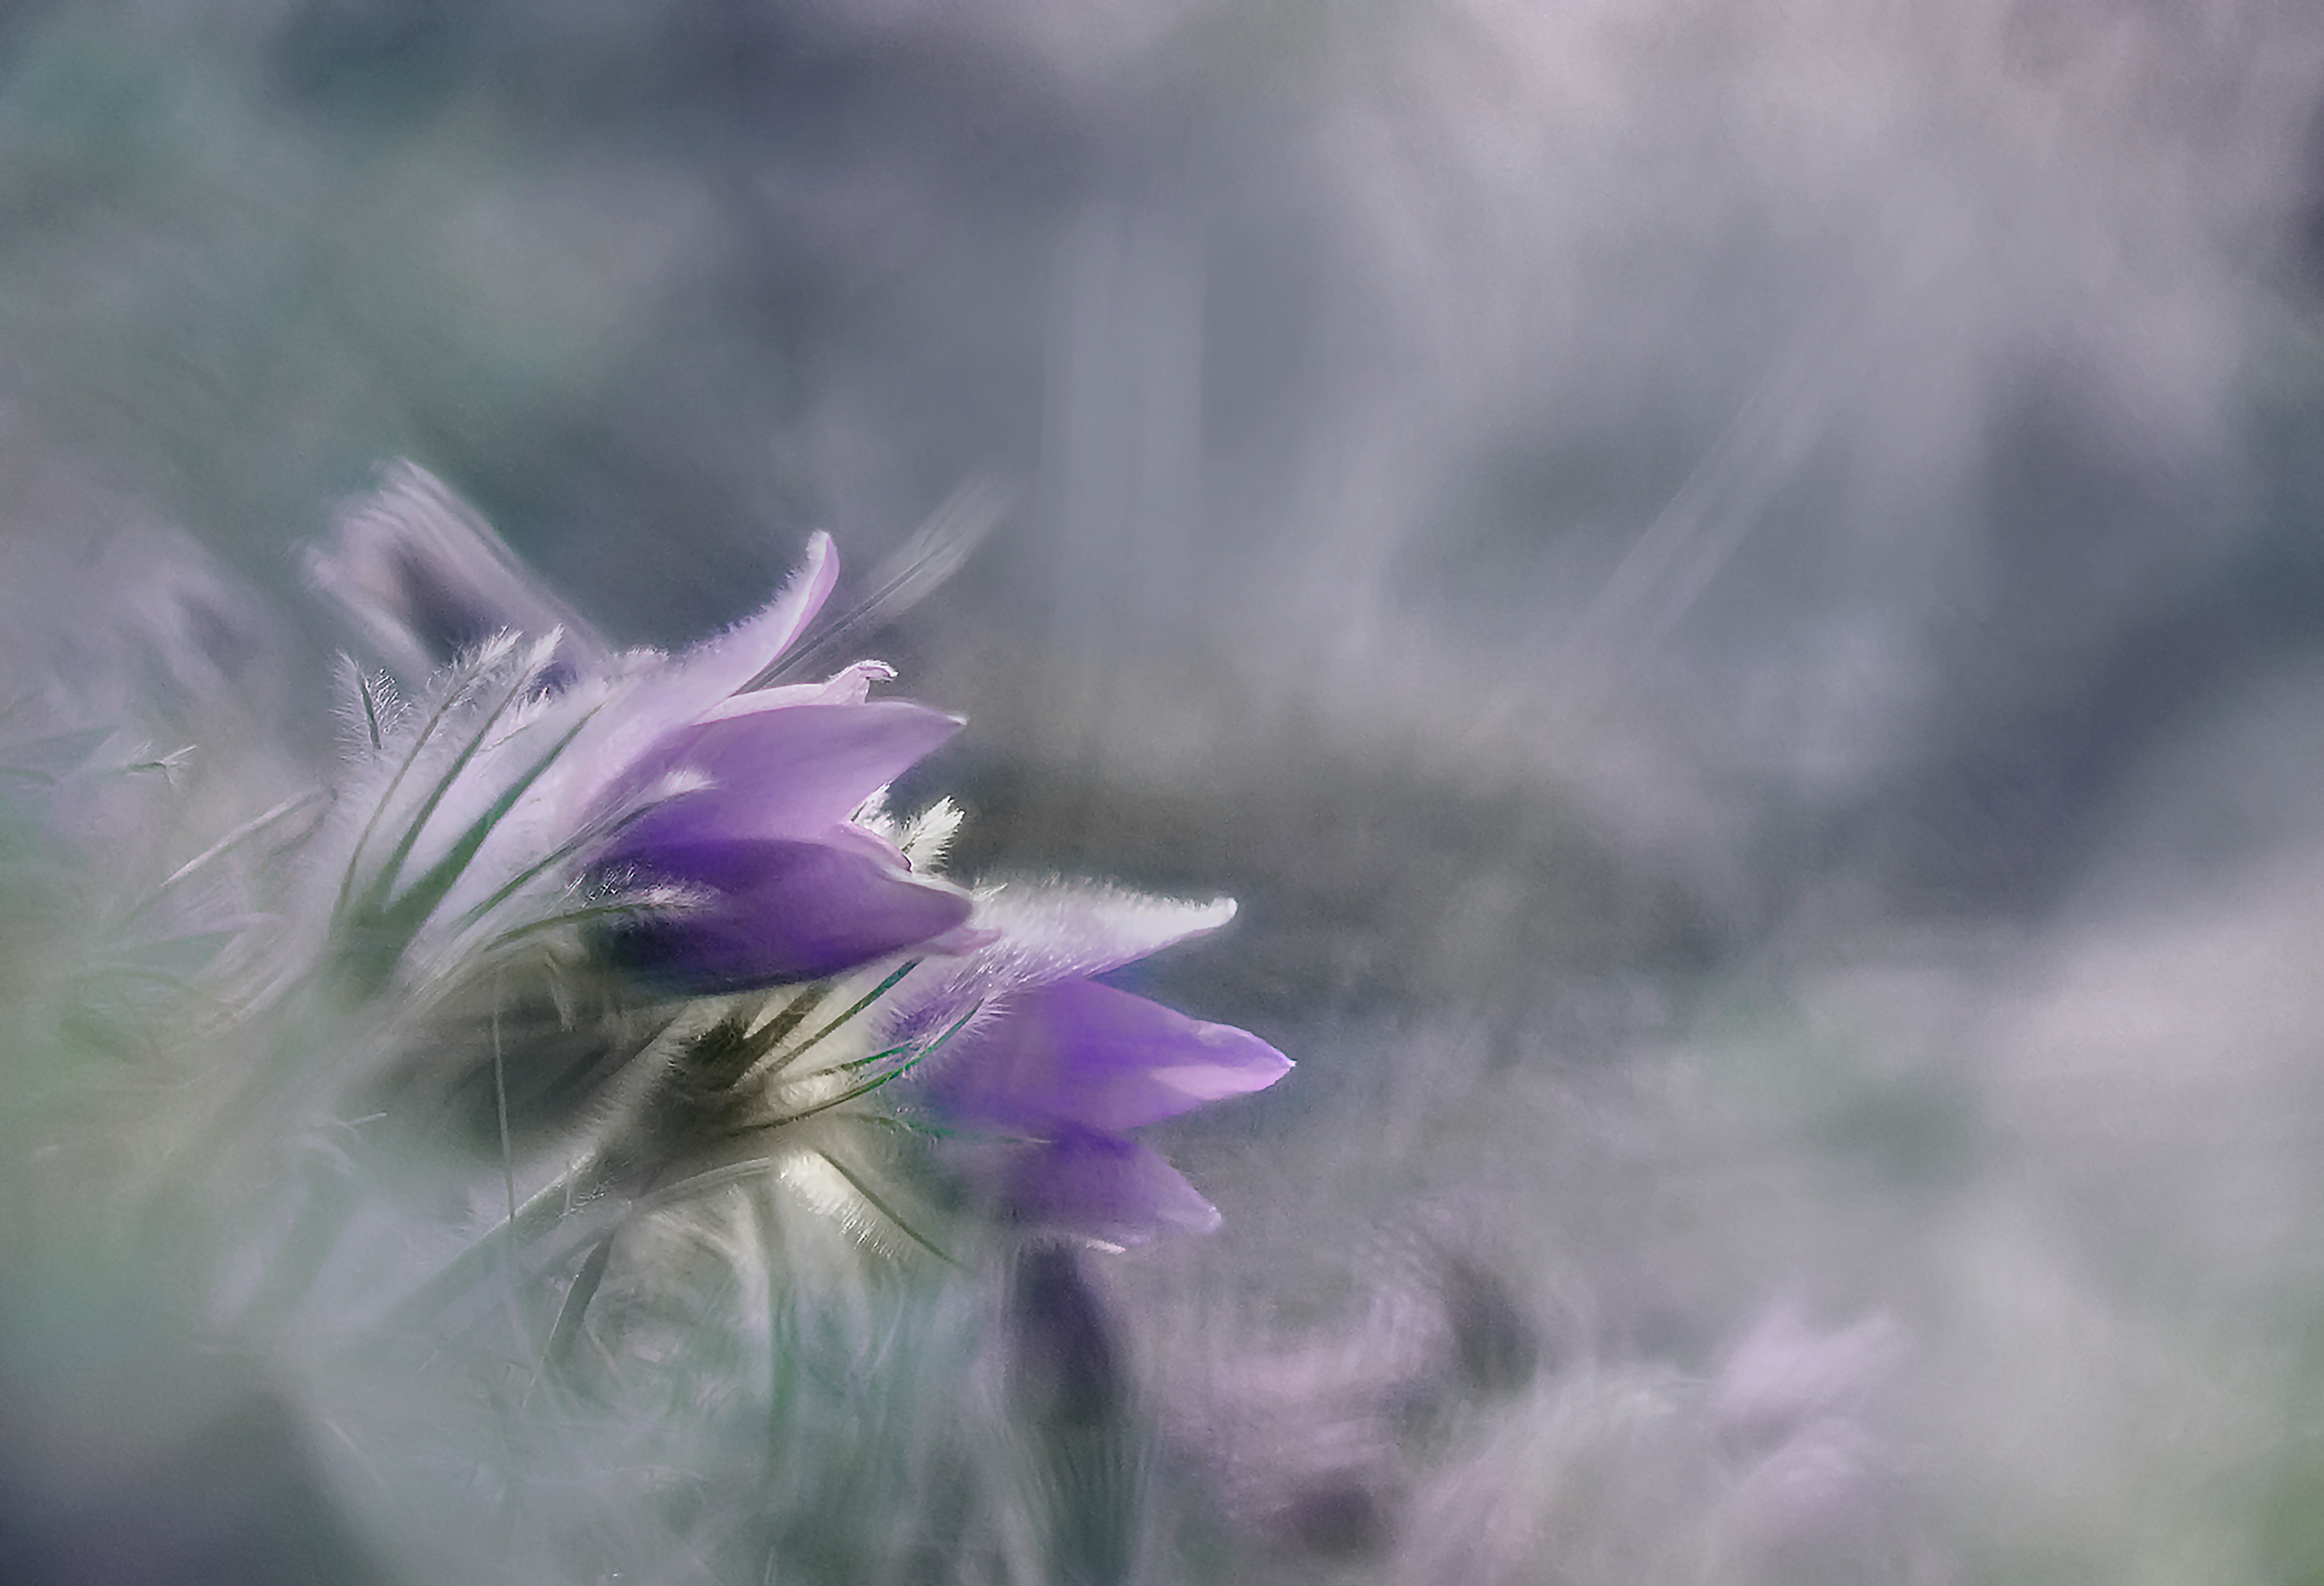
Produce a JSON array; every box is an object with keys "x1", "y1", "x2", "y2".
[{"x1": 886, "y1": 882, "x2": 1234, "y2": 1028}]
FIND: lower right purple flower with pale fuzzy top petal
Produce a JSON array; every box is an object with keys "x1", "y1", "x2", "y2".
[{"x1": 890, "y1": 888, "x2": 1292, "y2": 1247}]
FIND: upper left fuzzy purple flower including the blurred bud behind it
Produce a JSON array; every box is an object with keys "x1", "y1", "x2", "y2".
[{"x1": 312, "y1": 463, "x2": 974, "y2": 993}]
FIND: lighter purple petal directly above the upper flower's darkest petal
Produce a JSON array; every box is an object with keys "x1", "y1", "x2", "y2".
[{"x1": 602, "y1": 695, "x2": 962, "y2": 853}]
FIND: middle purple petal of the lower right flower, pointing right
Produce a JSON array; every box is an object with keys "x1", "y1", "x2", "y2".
[{"x1": 934, "y1": 981, "x2": 1292, "y2": 1130}]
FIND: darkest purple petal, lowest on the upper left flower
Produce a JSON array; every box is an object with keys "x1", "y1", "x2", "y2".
[{"x1": 607, "y1": 839, "x2": 971, "y2": 991}]
